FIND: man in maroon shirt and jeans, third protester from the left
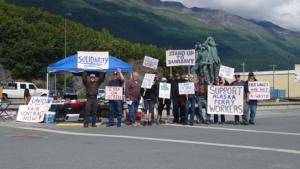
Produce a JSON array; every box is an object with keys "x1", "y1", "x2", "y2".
[{"x1": 125, "y1": 72, "x2": 141, "y2": 127}]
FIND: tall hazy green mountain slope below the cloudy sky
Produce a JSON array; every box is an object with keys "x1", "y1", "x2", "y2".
[{"x1": 3, "y1": 0, "x2": 300, "y2": 71}]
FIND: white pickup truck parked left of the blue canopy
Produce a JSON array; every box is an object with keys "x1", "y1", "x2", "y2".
[{"x1": 3, "y1": 82, "x2": 49, "y2": 99}]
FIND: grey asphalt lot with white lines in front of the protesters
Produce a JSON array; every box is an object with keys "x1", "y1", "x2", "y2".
[{"x1": 0, "y1": 108, "x2": 300, "y2": 169}]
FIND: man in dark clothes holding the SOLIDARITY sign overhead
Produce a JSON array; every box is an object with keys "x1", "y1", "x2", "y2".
[{"x1": 82, "y1": 71, "x2": 105, "y2": 128}]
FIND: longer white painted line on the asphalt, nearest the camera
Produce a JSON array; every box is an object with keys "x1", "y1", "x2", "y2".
[{"x1": 16, "y1": 127, "x2": 300, "y2": 155}]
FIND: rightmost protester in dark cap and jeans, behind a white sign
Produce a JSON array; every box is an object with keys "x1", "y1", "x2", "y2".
[{"x1": 244, "y1": 72, "x2": 257, "y2": 125}]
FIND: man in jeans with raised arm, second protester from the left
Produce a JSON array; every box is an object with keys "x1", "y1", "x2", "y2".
[{"x1": 105, "y1": 69, "x2": 124, "y2": 127}]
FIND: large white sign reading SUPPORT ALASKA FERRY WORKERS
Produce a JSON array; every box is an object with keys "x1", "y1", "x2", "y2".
[{"x1": 207, "y1": 85, "x2": 244, "y2": 115}]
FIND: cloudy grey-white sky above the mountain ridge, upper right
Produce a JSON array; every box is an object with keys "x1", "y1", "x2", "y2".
[{"x1": 169, "y1": 0, "x2": 300, "y2": 31}]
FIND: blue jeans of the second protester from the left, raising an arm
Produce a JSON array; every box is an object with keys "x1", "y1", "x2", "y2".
[{"x1": 108, "y1": 100, "x2": 123, "y2": 125}]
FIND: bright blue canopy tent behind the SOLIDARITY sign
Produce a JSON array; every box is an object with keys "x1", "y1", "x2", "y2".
[{"x1": 47, "y1": 54, "x2": 132, "y2": 89}]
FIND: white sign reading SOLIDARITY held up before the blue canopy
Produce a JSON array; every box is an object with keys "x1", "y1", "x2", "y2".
[{"x1": 77, "y1": 51, "x2": 109, "y2": 70}]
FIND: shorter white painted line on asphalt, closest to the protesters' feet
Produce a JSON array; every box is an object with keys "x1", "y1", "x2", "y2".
[{"x1": 165, "y1": 124, "x2": 300, "y2": 136}]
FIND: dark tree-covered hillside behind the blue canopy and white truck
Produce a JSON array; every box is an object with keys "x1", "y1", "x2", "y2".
[{"x1": 0, "y1": 0, "x2": 165, "y2": 80}]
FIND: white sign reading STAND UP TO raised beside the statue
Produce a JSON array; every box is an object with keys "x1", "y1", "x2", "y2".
[{"x1": 166, "y1": 49, "x2": 196, "y2": 67}]
